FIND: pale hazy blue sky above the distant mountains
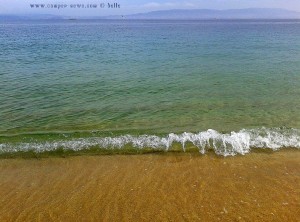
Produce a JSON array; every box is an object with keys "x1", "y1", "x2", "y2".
[{"x1": 0, "y1": 0, "x2": 300, "y2": 16}]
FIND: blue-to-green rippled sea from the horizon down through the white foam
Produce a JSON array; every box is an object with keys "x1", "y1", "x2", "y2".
[{"x1": 0, "y1": 20, "x2": 300, "y2": 155}]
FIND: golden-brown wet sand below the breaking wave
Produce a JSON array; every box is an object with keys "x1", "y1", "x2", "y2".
[{"x1": 0, "y1": 150, "x2": 300, "y2": 221}]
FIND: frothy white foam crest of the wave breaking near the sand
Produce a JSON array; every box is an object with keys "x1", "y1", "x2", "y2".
[{"x1": 0, "y1": 128, "x2": 300, "y2": 156}]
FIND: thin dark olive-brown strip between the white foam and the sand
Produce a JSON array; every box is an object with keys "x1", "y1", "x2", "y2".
[{"x1": 0, "y1": 147, "x2": 299, "y2": 160}]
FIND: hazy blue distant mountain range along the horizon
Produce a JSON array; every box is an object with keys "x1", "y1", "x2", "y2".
[{"x1": 0, "y1": 8, "x2": 300, "y2": 21}]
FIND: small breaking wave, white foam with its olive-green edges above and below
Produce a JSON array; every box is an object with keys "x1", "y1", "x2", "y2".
[{"x1": 0, "y1": 127, "x2": 300, "y2": 158}]
